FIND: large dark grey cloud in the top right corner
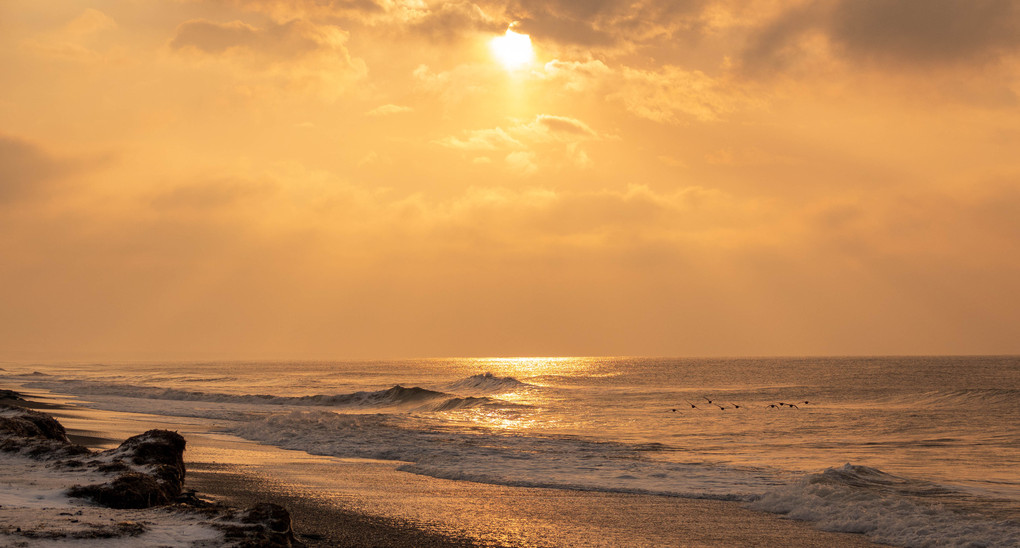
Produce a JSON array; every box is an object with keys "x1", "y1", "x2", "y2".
[{"x1": 742, "y1": 0, "x2": 1020, "y2": 73}]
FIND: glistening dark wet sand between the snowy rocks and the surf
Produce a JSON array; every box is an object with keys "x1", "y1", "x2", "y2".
[{"x1": 189, "y1": 455, "x2": 876, "y2": 548}]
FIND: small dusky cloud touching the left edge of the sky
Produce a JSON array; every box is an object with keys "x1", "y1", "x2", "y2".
[{"x1": 0, "y1": 135, "x2": 72, "y2": 204}]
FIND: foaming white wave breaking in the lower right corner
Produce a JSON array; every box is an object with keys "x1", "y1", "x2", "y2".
[{"x1": 749, "y1": 463, "x2": 1020, "y2": 546}]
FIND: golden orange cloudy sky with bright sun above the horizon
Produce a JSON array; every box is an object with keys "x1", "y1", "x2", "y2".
[{"x1": 0, "y1": 0, "x2": 1020, "y2": 360}]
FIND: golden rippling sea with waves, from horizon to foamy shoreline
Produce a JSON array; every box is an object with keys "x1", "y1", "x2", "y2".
[{"x1": 0, "y1": 357, "x2": 1020, "y2": 546}]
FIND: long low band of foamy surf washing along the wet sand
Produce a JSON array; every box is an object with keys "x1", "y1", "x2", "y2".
[{"x1": 228, "y1": 410, "x2": 781, "y2": 500}]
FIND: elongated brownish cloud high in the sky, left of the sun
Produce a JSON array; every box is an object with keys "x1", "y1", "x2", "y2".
[{"x1": 170, "y1": 19, "x2": 345, "y2": 57}]
